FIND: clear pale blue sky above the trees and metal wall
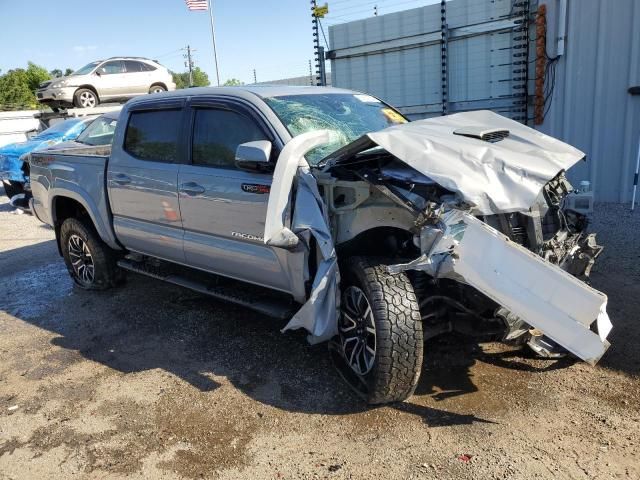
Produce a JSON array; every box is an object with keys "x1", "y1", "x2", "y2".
[{"x1": 0, "y1": 0, "x2": 435, "y2": 84}]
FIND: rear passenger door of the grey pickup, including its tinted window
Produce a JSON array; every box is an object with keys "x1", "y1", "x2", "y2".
[{"x1": 107, "y1": 99, "x2": 186, "y2": 262}]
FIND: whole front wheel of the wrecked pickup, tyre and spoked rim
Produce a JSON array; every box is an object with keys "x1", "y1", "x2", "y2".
[{"x1": 338, "y1": 257, "x2": 423, "y2": 404}]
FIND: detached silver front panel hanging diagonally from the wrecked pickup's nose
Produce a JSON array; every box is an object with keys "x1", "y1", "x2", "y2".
[{"x1": 391, "y1": 210, "x2": 612, "y2": 364}]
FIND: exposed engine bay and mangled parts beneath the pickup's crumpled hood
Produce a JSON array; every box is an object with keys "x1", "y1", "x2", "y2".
[{"x1": 319, "y1": 148, "x2": 602, "y2": 357}]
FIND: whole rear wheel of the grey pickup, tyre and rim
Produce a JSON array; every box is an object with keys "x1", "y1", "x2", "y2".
[{"x1": 60, "y1": 218, "x2": 122, "y2": 290}]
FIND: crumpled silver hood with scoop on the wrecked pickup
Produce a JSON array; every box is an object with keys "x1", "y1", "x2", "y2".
[{"x1": 343, "y1": 110, "x2": 585, "y2": 215}]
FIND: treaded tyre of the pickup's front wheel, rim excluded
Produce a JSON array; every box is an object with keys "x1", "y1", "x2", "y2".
[{"x1": 342, "y1": 257, "x2": 424, "y2": 404}]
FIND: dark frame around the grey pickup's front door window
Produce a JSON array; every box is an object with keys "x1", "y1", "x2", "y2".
[{"x1": 185, "y1": 97, "x2": 283, "y2": 172}]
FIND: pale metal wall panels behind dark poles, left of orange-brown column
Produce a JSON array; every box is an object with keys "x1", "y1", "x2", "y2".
[{"x1": 329, "y1": 0, "x2": 527, "y2": 119}]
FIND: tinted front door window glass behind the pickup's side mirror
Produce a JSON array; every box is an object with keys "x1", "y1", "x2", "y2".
[{"x1": 192, "y1": 109, "x2": 269, "y2": 168}]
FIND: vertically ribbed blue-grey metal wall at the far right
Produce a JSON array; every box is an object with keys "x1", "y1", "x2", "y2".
[{"x1": 539, "y1": 0, "x2": 640, "y2": 202}]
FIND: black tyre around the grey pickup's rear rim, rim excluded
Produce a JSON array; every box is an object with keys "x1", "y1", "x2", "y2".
[{"x1": 59, "y1": 218, "x2": 124, "y2": 290}]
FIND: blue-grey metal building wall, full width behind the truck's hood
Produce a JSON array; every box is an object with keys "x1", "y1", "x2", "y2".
[{"x1": 327, "y1": 0, "x2": 640, "y2": 202}]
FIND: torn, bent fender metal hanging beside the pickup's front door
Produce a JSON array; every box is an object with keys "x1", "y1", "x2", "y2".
[{"x1": 264, "y1": 130, "x2": 340, "y2": 344}]
